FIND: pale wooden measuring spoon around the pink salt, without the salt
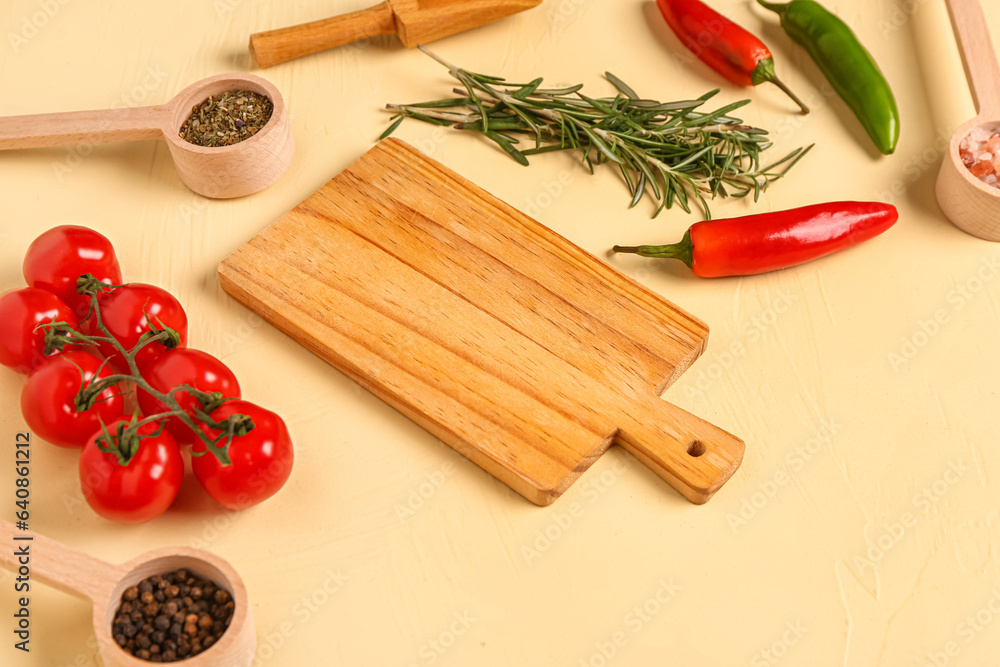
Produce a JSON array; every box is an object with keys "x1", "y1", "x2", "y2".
[{"x1": 937, "y1": 0, "x2": 1000, "y2": 241}]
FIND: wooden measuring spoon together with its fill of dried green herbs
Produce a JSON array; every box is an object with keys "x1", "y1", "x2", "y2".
[{"x1": 0, "y1": 74, "x2": 295, "y2": 199}]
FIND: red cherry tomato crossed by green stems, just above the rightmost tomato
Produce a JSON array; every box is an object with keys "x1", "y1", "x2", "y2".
[{"x1": 139, "y1": 348, "x2": 240, "y2": 444}]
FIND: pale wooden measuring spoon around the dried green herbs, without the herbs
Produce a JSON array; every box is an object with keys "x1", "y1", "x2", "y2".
[{"x1": 0, "y1": 74, "x2": 295, "y2": 199}]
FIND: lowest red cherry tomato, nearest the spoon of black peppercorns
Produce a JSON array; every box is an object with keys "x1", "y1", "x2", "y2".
[{"x1": 79, "y1": 419, "x2": 184, "y2": 523}]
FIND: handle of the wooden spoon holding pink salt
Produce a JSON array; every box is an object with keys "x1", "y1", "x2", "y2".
[{"x1": 946, "y1": 0, "x2": 1000, "y2": 118}]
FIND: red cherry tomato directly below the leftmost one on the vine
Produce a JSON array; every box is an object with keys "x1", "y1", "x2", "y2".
[{"x1": 21, "y1": 350, "x2": 125, "y2": 447}]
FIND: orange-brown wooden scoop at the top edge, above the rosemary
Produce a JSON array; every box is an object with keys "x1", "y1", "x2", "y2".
[{"x1": 250, "y1": 0, "x2": 542, "y2": 67}]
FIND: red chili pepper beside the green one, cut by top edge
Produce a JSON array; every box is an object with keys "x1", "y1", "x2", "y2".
[{"x1": 656, "y1": 0, "x2": 809, "y2": 113}]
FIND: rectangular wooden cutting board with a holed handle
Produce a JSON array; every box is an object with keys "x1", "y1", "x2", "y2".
[{"x1": 219, "y1": 139, "x2": 744, "y2": 505}]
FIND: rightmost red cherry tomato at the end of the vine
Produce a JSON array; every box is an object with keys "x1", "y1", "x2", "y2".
[{"x1": 191, "y1": 401, "x2": 294, "y2": 510}]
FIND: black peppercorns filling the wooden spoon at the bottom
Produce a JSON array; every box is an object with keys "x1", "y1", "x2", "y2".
[{"x1": 111, "y1": 570, "x2": 235, "y2": 662}]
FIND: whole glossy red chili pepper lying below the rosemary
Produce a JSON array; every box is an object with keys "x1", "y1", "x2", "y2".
[{"x1": 613, "y1": 201, "x2": 899, "y2": 278}]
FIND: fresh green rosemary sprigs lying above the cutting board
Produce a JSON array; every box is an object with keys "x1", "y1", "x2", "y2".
[{"x1": 379, "y1": 46, "x2": 812, "y2": 218}]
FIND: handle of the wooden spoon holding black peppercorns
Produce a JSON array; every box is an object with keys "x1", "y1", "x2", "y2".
[{"x1": 0, "y1": 521, "x2": 120, "y2": 603}]
